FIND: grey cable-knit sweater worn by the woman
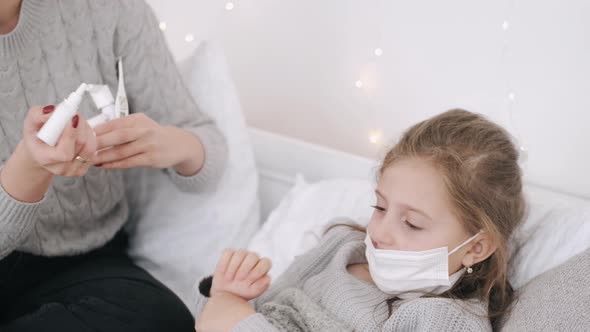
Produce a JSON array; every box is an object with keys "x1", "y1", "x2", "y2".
[{"x1": 0, "y1": 0, "x2": 227, "y2": 258}]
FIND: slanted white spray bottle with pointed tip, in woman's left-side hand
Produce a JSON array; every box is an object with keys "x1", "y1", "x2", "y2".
[{"x1": 37, "y1": 83, "x2": 86, "y2": 146}]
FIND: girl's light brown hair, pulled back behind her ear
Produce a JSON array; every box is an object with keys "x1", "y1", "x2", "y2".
[{"x1": 379, "y1": 109, "x2": 526, "y2": 327}]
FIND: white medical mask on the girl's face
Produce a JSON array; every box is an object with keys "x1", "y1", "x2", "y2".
[{"x1": 365, "y1": 231, "x2": 482, "y2": 296}]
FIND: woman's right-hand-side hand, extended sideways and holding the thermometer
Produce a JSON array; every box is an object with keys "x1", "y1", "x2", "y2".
[{"x1": 92, "y1": 113, "x2": 205, "y2": 176}]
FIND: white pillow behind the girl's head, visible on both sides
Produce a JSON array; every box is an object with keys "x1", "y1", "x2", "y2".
[{"x1": 249, "y1": 177, "x2": 590, "y2": 288}]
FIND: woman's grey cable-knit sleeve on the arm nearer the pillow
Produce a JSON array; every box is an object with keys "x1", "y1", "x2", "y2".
[{"x1": 114, "y1": 0, "x2": 227, "y2": 192}]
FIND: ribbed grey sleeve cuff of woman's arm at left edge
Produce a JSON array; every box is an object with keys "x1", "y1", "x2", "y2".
[{"x1": 0, "y1": 165, "x2": 45, "y2": 259}]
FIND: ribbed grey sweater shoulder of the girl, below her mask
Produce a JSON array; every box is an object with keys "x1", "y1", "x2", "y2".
[{"x1": 383, "y1": 298, "x2": 492, "y2": 332}]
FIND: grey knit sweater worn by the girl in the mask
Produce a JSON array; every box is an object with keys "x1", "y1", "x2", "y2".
[{"x1": 194, "y1": 227, "x2": 492, "y2": 332}]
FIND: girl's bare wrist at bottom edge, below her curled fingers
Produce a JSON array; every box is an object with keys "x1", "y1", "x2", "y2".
[{"x1": 195, "y1": 292, "x2": 256, "y2": 332}]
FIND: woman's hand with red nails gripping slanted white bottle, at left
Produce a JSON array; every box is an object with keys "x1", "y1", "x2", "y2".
[{"x1": 23, "y1": 105, "x2": 97, "y2": 176}]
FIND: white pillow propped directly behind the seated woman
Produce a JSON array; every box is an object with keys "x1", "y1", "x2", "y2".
[{"x1": 126, "y1": 42, "x2": 259, "y2": 316}]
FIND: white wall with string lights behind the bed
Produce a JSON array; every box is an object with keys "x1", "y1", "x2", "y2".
[{"x1": 148, "y1": 0, "x2": 590, "y2": 197}]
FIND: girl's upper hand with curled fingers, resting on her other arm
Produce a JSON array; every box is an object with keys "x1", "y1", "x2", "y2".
[{"x1": 211, "y1": 249, "x2": 271, "y2": 301}]
